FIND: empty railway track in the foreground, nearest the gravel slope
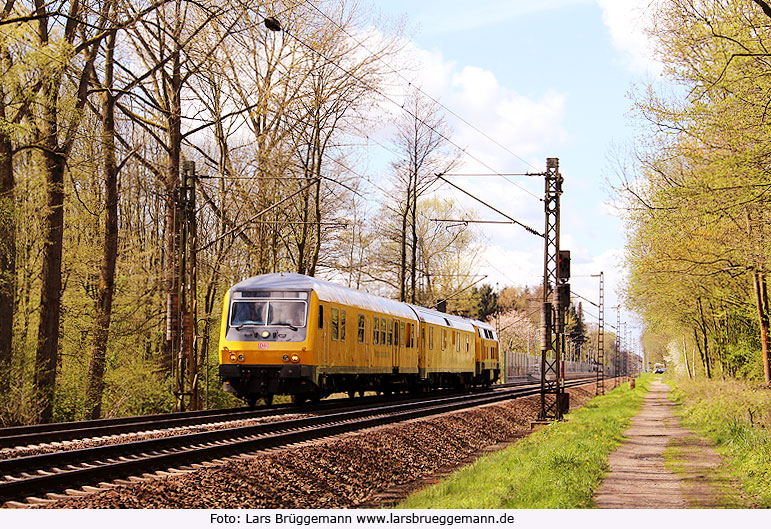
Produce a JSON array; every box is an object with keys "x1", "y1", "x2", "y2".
[{"x1": 0, "y1": 380, "x2": 587, "y2": 503}]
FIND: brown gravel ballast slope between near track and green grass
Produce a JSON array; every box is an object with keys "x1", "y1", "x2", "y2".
[{"x1": 37, "y1": 384, "x2": 594, "y2": 509}]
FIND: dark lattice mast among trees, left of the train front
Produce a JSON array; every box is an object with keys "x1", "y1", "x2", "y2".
[{"x1": 174, "y1": 160, "x2": 201, "y2": 411}]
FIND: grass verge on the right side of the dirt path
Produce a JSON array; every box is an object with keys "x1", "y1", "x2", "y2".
[{"x1": 667, "y1": 378, "x2": 771, "y2": 508}]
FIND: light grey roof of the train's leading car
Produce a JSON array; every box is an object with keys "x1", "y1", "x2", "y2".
[{"x1": 230, "y1": 272, "x2": 417, "y2": 320}]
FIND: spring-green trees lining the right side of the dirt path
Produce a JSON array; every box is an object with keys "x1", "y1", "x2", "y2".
[{"x1": 616, "y1": 0, "x2": 771, "y2": 384}]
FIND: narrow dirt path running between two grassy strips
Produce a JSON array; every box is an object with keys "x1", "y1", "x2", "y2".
[{"x1": 594, "y1": 380, "x2": 742, "y2": 509}]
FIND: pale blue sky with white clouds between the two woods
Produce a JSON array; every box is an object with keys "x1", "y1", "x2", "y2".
[{"x1": 358, "y1": 0, "x2": 658, "y2": 342}]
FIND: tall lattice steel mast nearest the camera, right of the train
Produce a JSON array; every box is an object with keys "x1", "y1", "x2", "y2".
[{"x1": 538, "y1": 158, "x2": 570, "y2": 422}]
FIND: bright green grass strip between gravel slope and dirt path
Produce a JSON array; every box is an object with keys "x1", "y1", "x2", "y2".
[{"x1": 397, "y1": 375, "x2": 650, "y2": 509}]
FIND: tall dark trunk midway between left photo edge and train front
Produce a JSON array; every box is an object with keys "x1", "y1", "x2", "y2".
[{"x1": 86, "y1": 33, "x2": 118, "y2": 419}]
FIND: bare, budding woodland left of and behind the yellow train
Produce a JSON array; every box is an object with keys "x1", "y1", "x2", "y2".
[{"x1": 0, "y1": 0, "x2": 524, "y2": 425}]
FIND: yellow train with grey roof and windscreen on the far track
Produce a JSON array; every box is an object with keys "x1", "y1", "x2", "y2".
[{"x1": 219, "y1": 272, "x2": 500, "y2": 406}]
